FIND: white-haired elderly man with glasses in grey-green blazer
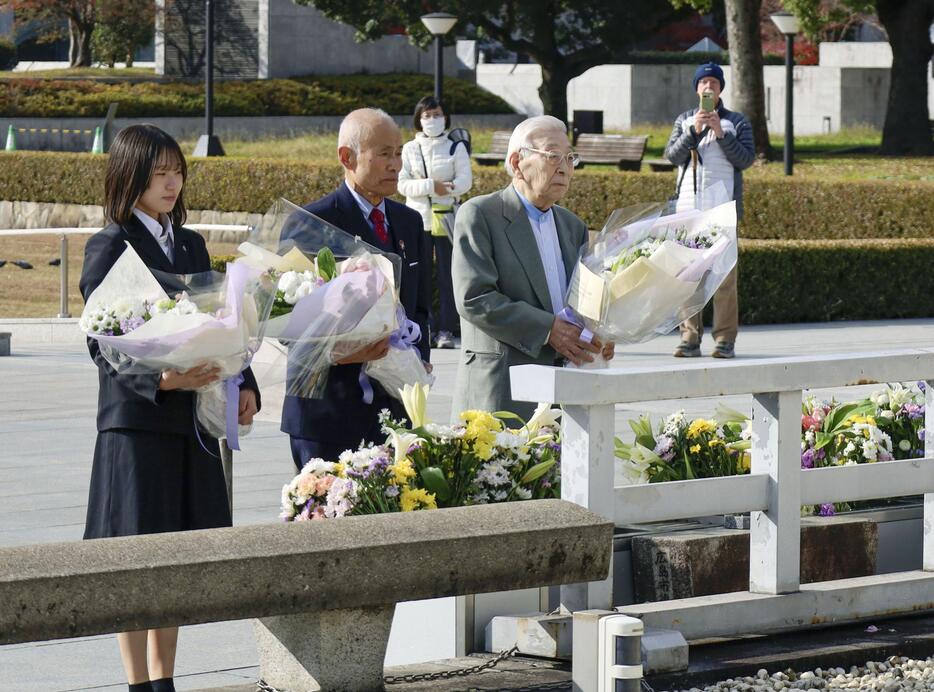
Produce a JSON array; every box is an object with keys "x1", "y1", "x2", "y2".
[{"x1": 452, "y1": 116, "x2": 613, "y2": 419}]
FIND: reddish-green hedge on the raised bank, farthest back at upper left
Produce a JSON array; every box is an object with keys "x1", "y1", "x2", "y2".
[{"x1": 0, "y1": 73, "x2": 513, "y2": 118}]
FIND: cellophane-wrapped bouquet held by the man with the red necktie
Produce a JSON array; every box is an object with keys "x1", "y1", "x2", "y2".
[{"x1": 235, "y1": 199, "x2": 430, "y2": 398}]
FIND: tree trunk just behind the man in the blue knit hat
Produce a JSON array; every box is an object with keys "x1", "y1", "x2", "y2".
[{"x1": 725, "y1": 0, "x2": 773, "y2": 160}]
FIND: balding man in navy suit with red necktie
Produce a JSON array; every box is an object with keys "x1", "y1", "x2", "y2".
[{"x1": 281, "y1": 108, "x2": 431, "y2": 469}]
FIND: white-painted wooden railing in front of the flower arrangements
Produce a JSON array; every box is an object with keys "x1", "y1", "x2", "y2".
[{"x1": 510, "y1": 348, "x2": 934, "y2": 611}]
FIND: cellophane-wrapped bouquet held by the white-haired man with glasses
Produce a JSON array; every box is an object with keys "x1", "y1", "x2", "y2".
[{"x1": 565, "y1": 185, "x2": 737, "y2": 343}]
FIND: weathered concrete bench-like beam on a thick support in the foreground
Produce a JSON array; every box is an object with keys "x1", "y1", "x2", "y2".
[{"x1": 0, "y1": 500, "x2": 613, "y2": 692}]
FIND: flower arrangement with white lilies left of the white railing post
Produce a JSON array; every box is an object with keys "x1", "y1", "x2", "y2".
[{"x1": 280, "y1": 385, "x2": 561, "y2": 521}]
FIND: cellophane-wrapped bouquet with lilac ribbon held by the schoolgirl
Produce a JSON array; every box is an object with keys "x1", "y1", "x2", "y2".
[{"x1": 79, "y1": 244, "x2": 274, "y2": 449}]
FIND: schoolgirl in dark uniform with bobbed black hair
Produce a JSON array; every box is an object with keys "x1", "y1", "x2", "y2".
[{"x1": 80, "y1": 125, "x2": 260, "y2": 692}]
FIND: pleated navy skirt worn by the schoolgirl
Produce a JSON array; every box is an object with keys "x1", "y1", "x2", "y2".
[{"x1": 84, "y1": 430, "x2": 232, "y2": 538}]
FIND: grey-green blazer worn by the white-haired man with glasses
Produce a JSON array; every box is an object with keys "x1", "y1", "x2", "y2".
[{"x1": 451, "y1": 185, "x2": 587, "y2": 420}]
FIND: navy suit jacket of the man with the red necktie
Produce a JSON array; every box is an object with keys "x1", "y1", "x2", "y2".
[{"x1": 281, "y1": 183, "x2": 431, "y2": 448}]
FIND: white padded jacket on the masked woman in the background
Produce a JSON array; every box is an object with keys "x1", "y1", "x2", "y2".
[{"x1": 399, "y1": 132, "x2": 473, "y2": 231}]
